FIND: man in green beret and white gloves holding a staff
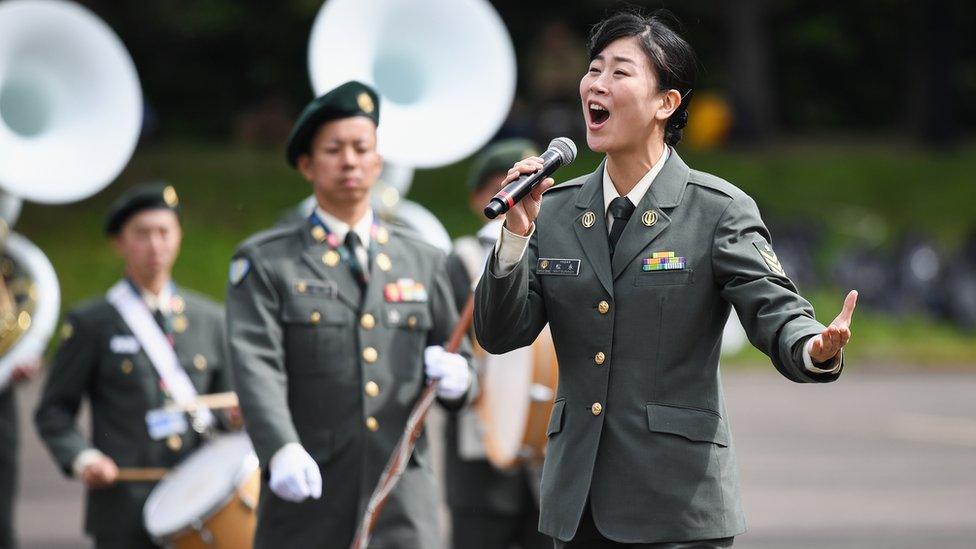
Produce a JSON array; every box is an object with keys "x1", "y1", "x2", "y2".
[{"x1": 227, "y1": 82, "x2": 474, "y2": 549}]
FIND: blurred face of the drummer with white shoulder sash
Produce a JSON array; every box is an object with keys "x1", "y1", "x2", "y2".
[{"x1": 112, "y1": 209, "x2": 183, "y2": 280}]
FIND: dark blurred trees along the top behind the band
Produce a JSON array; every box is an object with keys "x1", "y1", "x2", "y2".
[{"x1": 76, "y1": 0, "x2": 976, "y2": 147}]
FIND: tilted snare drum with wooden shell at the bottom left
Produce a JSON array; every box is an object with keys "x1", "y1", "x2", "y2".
[{"x1": 142, "y1": 433, "x2": 261, "y2": 549}]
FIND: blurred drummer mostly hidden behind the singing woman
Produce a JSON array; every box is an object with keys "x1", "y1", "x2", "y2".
[{"x1": 445, "y1": 139, "x2": 552, "y2": 549}]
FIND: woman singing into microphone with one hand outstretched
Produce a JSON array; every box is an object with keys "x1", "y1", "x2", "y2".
[{"x1": 475, "y1": 9, "x2": 857, "y2": 548}]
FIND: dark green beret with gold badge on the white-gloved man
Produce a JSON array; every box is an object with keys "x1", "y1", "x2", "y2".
[{"x1": 286, "y1": 80, "x2": 380, "y2": 166}]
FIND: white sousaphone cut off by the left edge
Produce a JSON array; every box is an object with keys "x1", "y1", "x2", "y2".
[{"x1": 0, "y1": 0, "x2": 142, "y2": 388}]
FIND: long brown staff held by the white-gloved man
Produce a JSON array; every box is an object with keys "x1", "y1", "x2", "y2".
[{"x1": 351, "y1": 293, "x2": 474, "y2": 549}]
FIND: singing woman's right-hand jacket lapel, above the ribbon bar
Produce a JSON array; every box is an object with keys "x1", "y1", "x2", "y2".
[{"x1": 601, "y1": 149, "x2": 690, "y2": 280}]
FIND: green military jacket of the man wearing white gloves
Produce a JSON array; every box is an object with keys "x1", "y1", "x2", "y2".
[{"x1": 227, "y1": 216, "x2": 474, "y2": 549}]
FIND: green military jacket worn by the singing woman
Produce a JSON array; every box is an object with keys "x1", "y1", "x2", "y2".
[{"x1": 475, "y1": 152, "x2": 839, "y2": 543}]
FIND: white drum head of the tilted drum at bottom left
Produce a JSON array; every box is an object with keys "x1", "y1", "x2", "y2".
[{"x1": 142, "y1": 433, "x2": 258, "y2": 539}]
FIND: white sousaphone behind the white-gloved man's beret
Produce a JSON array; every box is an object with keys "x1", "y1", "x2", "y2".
[{"x1": 308, "y1": 0, "x2": 516, "y2": 251}]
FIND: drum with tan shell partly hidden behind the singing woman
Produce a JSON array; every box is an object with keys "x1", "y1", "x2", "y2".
[{"x1": 476, "y1": 325, "x2": 559, "y2": 469}]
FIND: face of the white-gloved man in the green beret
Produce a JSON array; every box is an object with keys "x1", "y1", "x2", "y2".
[{"x1": 298, "y1": 116, "x2": 383, "y2": 208}]
